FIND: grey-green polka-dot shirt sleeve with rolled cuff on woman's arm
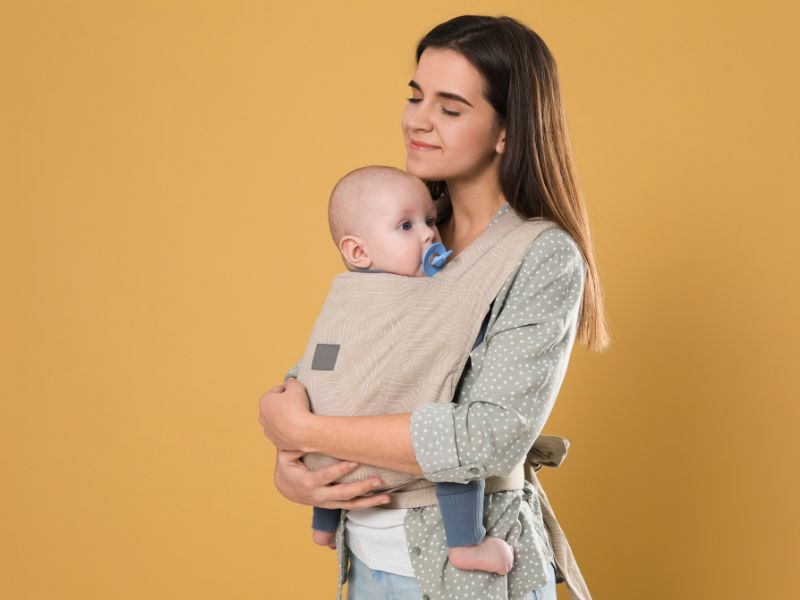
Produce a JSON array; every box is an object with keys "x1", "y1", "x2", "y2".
[{"x1": 411, "y1": 229, "x2": 586, "y2": 483}]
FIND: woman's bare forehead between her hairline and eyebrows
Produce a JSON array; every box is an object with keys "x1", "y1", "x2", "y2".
[{"x1": 412, "y1": 48, "x2": 483, "y2": 102}]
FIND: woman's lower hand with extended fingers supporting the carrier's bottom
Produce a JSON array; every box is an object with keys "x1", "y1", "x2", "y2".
[{"x1": 275, "y1": 450, "x2": 389, "y2": 510}]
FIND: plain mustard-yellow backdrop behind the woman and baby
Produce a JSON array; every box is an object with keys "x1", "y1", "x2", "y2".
[{"x1": 0, "y1": 0, "x2": 800, "y2": 600}]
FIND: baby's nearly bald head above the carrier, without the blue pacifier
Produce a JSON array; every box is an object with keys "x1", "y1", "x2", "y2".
[{"x1": 328, "y1": 166, "x2": 441, "y2": 276}]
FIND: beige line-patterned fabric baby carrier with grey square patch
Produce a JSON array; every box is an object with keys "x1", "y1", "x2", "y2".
[{"x1": 297, "y1": 208, "x2": 557, "y2": 508}]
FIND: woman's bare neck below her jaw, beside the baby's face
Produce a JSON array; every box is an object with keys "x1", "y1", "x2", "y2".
[{"x1": 439, "y1": 170, "x2": 506, "y2": 256}]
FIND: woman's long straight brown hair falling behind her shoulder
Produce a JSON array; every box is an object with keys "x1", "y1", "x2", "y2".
[{"x1": 416, "y1": 15, "x2": 611, "y2": 352}]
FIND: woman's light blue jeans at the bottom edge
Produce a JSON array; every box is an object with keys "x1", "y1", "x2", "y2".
[{"x1": 347, "y1": 552, "x2": 556, "y2": 600}]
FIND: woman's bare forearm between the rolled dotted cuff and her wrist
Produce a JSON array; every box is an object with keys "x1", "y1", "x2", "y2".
[{"x1": 300, "y1": 413, "x2": 422, "y2": 475}]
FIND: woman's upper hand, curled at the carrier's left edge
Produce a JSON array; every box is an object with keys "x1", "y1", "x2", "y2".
[{"x1": 258, "y1": 378, "x2": 314, "y2": 450}]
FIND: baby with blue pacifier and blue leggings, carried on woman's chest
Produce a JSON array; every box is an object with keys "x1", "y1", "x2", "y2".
[{"x1": 304, "y1": 166, "x2": 514, "y2": 575}]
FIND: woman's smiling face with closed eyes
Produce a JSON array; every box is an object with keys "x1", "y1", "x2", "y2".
[{"x1": 401, "y1": 48, "x2": 505, "y2": 185}]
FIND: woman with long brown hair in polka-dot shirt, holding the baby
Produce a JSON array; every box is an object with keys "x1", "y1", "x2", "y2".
[{"x1": 259, "y1": 16, "x2": 609, "y2": 600}]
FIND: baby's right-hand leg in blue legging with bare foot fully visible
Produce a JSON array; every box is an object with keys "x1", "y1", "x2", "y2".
[{"x1": 436, "y1": 479, "x2": 514, "y2": 575}]
